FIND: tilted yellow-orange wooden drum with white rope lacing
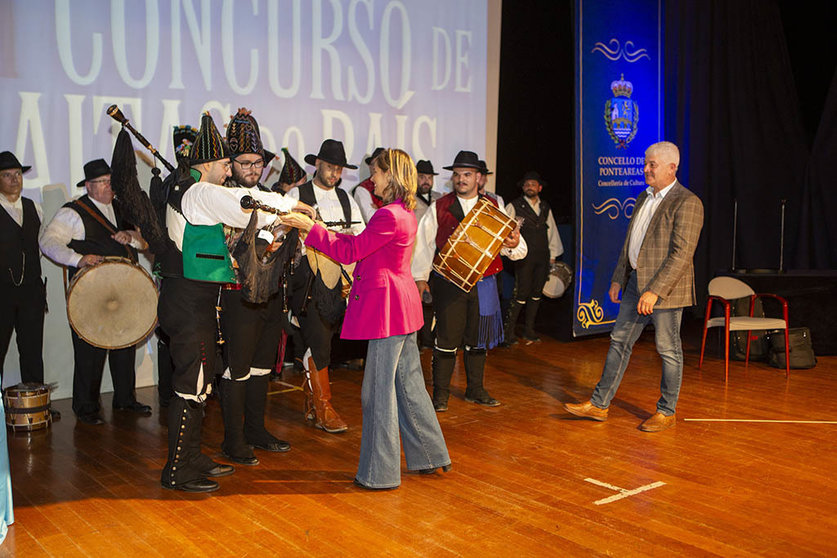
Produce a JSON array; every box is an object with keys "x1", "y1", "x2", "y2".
[{"x1": 433, "y1": 198, "x2": 515, "y2": 293}]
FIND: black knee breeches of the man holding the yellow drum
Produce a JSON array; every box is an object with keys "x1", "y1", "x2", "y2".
[{"x1": 430, "y1": 272, "x2": 480, "y2": 350}]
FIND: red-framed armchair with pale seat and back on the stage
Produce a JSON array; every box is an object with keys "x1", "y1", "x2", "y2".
[{"x1": 698, "y1": 277, "x2": 790, "y2": 382}]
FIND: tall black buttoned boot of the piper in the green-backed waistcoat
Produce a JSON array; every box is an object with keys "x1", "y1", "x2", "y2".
[{"x1": 160, "y1": 397, "x2": 218, "y2": 492}]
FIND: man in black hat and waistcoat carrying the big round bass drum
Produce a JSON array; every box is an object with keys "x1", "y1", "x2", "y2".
[{"x1": 40, "y1": 159, "x2": 151, "y2": 425}]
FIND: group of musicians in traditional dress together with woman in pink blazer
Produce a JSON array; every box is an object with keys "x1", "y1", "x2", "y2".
[{"x1": 0, "y1": 109, "x2": 527, "y2": 492}]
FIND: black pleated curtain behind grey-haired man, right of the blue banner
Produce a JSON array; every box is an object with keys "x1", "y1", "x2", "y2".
[{"x1": 664, "y1": 0, "x2": 808, "y2": 294}]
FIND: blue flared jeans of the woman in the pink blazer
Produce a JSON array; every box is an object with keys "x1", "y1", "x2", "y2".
[{"x1": 356, "y1": 333, "x2": 450, "y2": 488}]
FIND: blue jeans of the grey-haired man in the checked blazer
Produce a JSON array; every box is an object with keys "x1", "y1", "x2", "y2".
[{"x1": 590, "y1": 272, "x2": 683, "y2": 416}]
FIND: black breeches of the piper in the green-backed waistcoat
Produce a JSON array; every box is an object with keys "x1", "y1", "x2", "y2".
[{"x1": 157, "y1": 277, "x2": 220, "y2": 399}]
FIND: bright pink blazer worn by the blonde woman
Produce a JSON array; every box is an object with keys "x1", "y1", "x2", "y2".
[{"x1": 305, "y1": 200, "x2": 424, "y2": 339}]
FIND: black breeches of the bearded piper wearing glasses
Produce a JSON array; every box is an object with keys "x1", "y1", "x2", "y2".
[{"x1": 221, "y1": 289, "x2": 287, "y2": 380}]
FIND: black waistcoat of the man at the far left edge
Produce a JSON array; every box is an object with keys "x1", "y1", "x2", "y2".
[{"x1": 0, "y1": 198, "x2": 41, "y2": 287}]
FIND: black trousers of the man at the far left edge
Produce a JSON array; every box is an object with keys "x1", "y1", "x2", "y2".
[{"x1": 0, "y1": 277, "x2": 46, "y2": 384}]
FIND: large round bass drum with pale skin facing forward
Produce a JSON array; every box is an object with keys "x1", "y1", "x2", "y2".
[{"x1": 67, "y1": 257, "x2": 157, "y2": 349}]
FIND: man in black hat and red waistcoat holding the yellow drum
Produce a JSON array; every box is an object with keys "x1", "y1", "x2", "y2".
[{"x1": 412, "y1": 151, "x2": 527, "y2": 412}]
